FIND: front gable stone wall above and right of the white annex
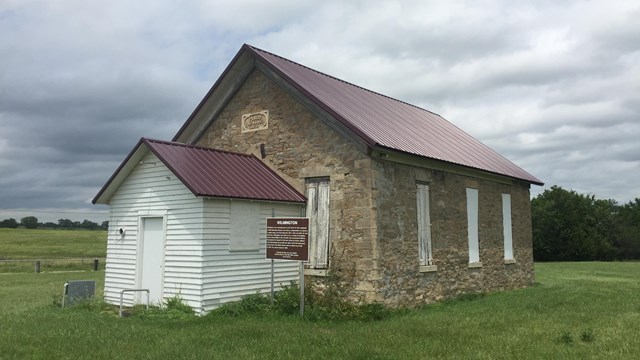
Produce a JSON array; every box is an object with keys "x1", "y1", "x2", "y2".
[{"x1": 197, "y1": 70, "x2": 378, "y2": 298}]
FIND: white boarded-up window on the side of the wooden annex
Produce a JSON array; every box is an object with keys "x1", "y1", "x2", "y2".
[{"x1": 229, "y1": 201, "x2": 260, "y2": 251}]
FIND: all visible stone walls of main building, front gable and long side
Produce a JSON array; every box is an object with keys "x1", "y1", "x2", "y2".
[{"x1": 197, "y1": 65, "x2": 534, "y2": 306}]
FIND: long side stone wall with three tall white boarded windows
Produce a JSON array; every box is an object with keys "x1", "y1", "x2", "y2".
[{"x1": 374, "y1": 160, "x2": 535, "y2": 306}]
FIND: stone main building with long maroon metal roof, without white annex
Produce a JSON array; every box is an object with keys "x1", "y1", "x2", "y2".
[{"x1": 173, "y1": 45, "x2": 542, "y2": 306}]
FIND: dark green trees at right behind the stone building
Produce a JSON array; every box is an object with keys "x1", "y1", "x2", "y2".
[{"x1": 531, "y1": 186, "x2": 640, "y2": 261}]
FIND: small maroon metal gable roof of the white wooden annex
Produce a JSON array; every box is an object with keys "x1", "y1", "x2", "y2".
[{"x1": 93, "y1": 138, "x2": 306, "y2": 204}]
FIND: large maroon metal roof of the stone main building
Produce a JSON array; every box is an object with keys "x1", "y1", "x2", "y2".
[{"x1": 174, "y1": 44, "x2": 543, "y2": 185}]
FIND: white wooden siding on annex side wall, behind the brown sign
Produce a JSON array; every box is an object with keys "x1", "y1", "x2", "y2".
[{"x1": 202, "y1": 199, "x2": 301, "y2": 311}]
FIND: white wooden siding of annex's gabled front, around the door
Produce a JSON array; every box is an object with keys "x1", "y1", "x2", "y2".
[{"x1": 104, "y1": 153, "x2": 203, "y2": 309}]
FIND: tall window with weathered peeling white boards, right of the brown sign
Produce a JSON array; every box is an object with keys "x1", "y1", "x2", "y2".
[{"x1": 306, "y1": 178, "x2": 329, "y2": 268}]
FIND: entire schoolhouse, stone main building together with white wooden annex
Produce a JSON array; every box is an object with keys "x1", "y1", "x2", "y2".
[{"x1": 94, "y1": 45, "x2": 542, "y2": 311}]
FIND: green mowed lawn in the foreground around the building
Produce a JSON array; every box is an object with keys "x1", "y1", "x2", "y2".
[{"x1": 0, "y1": 262, "x2": 640, "y2": 359}]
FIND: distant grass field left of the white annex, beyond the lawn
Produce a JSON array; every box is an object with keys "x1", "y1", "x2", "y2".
[{"x1": 0, "y1": 228, "x2": 107, "y2": 273}]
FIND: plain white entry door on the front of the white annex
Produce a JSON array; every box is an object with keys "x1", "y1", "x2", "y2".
[{"x1": 138, "y1": 217, "x2": 164, "y2": 304}]
